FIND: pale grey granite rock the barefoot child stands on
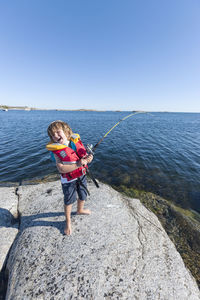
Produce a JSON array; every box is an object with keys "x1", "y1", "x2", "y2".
[{"x1": 0, "y1": 181, "x2": 200, "y2": 300}]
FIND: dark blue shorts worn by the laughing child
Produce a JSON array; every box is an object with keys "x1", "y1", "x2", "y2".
[{"x1": 62, "y1": 175, "x2": 87, "y2": 205}]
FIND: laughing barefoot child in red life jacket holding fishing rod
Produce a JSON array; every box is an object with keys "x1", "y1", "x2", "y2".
[{"x1": 46, "y1": 120, "x2": 93, "y2": 235}]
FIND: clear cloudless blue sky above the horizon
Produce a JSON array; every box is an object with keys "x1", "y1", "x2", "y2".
[{"x1": 0, "y1": 0, "x2": 200, "y2": 112}]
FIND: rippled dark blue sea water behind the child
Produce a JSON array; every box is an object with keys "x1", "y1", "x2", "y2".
[{"x1": 0, "y1": 110, "x2": 200, "y2": 211}]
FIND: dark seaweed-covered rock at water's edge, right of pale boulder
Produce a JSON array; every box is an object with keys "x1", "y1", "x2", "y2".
[{"x1": 114, "y1": 186, "x2": 200, "y2": 288}]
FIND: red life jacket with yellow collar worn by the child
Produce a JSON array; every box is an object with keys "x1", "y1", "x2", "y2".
[{"x1": 46, "y1": 134, "x2": 88, "y2": 181}]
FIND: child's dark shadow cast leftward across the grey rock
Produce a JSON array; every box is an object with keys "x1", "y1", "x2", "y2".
[{"x1": 0, "y1": 208, "x2": 76, "y2": 235}]
